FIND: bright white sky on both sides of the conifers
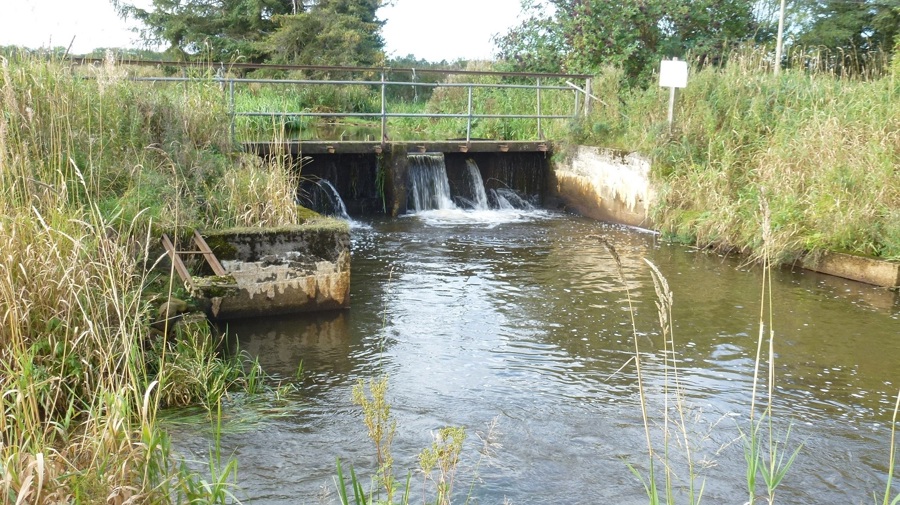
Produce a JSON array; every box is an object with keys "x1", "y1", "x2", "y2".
[{"x1": 0, "y1": 0, "x2": 520, "y2": 61}]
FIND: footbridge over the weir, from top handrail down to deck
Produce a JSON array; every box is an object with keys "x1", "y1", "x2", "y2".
[{"x1": 216, "y1": 66, "x2": 593, "y2": 155}]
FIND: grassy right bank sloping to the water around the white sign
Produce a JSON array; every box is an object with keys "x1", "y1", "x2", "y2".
[{"x1": 575, "y1": 47, "x2": 900, "y2": 260}]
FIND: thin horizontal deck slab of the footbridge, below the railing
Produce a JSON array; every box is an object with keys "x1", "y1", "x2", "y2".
[{"x1": 242, "y1": 139, "x2": 551, "y2": 156}]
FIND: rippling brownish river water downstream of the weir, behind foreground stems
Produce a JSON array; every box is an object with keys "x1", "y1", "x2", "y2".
[{"x1": 172, "y1": 209, "x2": 900, "y2": 505}]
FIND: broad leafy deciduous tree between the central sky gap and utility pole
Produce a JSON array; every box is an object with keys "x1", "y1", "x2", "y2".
[{"x1": 497, "y1": 0, "x2": 759, "y2": 80}]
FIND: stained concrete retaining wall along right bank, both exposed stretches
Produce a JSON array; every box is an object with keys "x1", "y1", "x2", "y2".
[{"x1": 553, "y1": 146, "x2": 900, "y2": 288}]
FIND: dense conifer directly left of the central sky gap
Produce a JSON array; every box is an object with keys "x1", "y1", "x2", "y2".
[{"x1": 258, "y1": 0, "x2": 384, "y2": 66}]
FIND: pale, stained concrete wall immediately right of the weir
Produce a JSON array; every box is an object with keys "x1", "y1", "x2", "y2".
[{"x1": 553, "y1": 146, "x2": 656, "y2": 228}]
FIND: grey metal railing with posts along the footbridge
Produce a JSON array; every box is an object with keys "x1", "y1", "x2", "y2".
[{"x1": 125, "y1": 62, "x2": 594, "y2": 145}]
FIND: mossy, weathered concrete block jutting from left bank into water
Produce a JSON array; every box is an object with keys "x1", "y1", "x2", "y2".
[{"x1": 195, "y1": 220, "x2": 350, "y2": 320}]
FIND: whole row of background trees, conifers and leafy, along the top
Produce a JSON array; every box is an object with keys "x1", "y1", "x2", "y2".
[{"x1": 111, "y1": 0, "x2": 900, "y2": 80}]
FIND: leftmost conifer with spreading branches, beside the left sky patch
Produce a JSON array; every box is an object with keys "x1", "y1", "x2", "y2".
[{"x1": 111, "y1": 0, "x2": 306, "y2": 62}]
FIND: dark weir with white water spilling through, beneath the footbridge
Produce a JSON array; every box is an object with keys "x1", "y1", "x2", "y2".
[{"x1": 297, "y1": 149, "x2": 552, "y2": 216}]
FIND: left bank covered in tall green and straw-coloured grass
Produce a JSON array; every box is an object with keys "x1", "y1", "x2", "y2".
[{"x1": 0, "y1": 51, "x2": 297, "y2": 503}]
